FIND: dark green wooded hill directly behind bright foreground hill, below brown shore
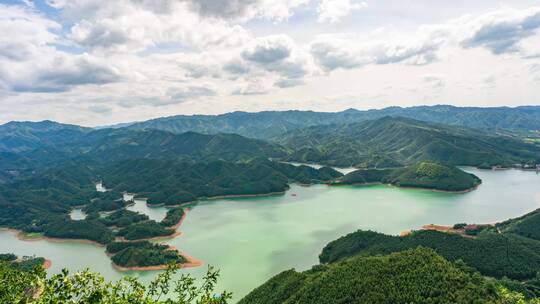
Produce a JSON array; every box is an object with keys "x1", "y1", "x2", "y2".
[{"x1": 319, "y1": 230, "x2": 540, "y2": 280}]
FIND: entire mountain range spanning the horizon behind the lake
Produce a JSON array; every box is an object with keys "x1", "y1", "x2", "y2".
[{"x1": 0, "y1": 106, "x2": 540, "y2": 178}]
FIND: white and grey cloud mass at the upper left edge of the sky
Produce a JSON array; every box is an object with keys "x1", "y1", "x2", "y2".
[{"x1": 0, "y1": 5, "x2": 122, "y2": 92}]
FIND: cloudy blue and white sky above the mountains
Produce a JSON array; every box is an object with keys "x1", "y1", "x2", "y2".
[{"x1": 0, "y1": 0, "x2": 540, "y2": 126}]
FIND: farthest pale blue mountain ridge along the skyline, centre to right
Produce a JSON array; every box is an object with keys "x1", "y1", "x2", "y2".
[{"x1": 120, "y1": 105, "x2": 540, "y2": 138}]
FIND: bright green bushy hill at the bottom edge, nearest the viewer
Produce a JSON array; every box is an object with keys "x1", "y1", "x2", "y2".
[{"x1": 239, "y1": 248, "x2": 499, "y2": 304}]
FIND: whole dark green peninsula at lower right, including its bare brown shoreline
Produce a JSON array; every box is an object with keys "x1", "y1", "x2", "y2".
[{"x1": 319, "y1": 209, "x2": 540, "y2": 297}]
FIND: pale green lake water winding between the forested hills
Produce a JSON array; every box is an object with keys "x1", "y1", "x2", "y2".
[{"x1": 0, "y1": 168, "x2": 540, "y2": 300}]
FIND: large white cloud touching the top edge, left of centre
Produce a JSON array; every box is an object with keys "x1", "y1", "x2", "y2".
[{"x1": 56, "y1": 0, "x2": 249, "y2": 52}]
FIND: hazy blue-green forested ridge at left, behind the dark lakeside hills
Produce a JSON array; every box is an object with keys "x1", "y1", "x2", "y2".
[{"x1": 0, "y1": 125, "x2": 287, "y2": 183}]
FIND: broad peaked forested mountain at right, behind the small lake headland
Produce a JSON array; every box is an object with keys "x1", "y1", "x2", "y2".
[{"x1": 274, "y1": 117, "x2": 540, "y2": 168}]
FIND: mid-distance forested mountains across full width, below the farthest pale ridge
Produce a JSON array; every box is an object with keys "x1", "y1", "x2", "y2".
[{"x1": 0, "y1": 111, "x2": 540, "y2": 178}]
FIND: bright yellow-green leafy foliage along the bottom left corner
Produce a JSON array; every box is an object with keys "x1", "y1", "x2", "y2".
[{"x1": 0, "y1": 262, "x2": 231, "y2": 304}]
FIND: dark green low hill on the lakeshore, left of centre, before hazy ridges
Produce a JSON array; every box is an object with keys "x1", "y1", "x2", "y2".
[{"x1": 102, "y1": 158, "x2": 341, "y2": 205}]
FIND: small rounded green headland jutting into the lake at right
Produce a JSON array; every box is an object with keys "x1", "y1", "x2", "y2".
[{"x1": 331, "y1": 162, "x2": 482, "y2": 192}]
